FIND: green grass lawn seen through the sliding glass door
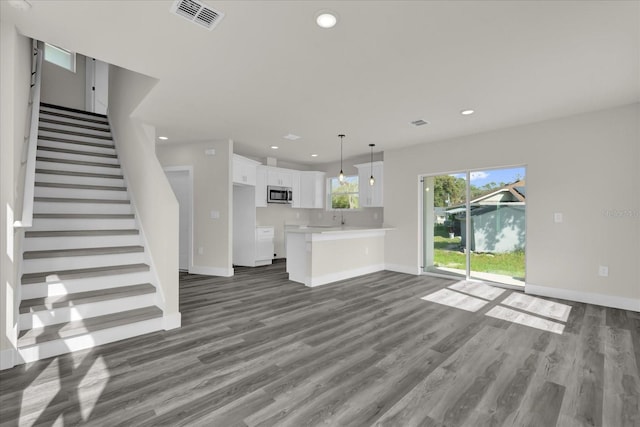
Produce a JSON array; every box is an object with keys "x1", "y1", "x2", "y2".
[{"x1": 433, "y1": 236, "x2": 524, "y2": 280}]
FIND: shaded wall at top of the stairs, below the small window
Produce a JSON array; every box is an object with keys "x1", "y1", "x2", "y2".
[{"x1": 40, "y1": 53, "x2": 87, "y2": 110}]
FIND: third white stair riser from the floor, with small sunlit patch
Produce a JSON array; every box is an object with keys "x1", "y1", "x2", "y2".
[{"x1": 22, "y1": 271, "x2": 151, "y2": 300}]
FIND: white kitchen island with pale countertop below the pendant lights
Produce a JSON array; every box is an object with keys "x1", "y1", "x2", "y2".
[{"x1": 286, "y1": 227, "x2": 391, "y2": 286}]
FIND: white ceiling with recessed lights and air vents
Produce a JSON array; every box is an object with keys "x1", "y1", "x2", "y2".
[{"x1": 0, "y1": 0, "x2": 640, "y2": 165}]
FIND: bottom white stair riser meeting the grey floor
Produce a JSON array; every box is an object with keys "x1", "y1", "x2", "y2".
[{"x1": 18, "y1": 318, "x2": 163, "y2": 363}]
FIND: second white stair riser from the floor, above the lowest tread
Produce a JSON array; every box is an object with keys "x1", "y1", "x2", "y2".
[{"x1": 19, "y1": 293, "x2": 156, "y2": 331}]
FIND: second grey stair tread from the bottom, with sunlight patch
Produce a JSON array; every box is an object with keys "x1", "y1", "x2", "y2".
[{"x1": 20, "y1": 283, "x2": 156, "y2": 314}]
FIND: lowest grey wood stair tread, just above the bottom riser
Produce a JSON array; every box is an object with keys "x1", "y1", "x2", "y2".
[{"x1": 18, "y1": 306, "x2": 162, "y2": 348}]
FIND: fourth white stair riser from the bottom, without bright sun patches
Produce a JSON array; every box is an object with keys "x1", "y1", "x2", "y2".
[{"x1": 22, "y1": 252, "x2": 145, "y2": 274}]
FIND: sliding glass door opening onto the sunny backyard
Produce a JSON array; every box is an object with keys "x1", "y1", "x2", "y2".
[{"x1": 422, "y1": 167, "x2": 526, "y2": 285}]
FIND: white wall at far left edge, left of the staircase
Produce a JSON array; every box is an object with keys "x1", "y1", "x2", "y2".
[{"x1": 0, "y1": 22, "x2": 31, "y2": 369}]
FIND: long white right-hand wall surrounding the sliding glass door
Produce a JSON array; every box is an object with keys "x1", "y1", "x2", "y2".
[{"x1": 384, "y1": 104, "x2": 640, "y2": 310}]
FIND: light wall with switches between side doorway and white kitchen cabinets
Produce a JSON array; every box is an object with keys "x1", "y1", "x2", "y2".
[{"x1": 156, "y1": 141, "x2": 233, "y2": 276}]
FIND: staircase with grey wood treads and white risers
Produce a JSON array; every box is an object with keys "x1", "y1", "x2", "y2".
[{"x1": 18, "y1": 103, "x2": 163, "y2": 363}]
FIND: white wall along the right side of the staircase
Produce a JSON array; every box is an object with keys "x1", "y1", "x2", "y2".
[{"x1": 109, "y1": 66, "x2": 180, "y2": 327}]
